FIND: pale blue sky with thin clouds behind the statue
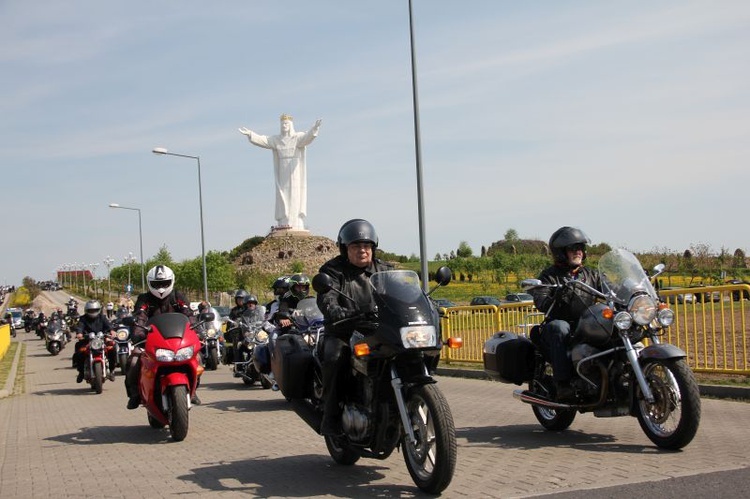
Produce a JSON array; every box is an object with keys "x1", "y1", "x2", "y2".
[{"x1": 0, "y1": 0, "x2": 750, "y2": 284}]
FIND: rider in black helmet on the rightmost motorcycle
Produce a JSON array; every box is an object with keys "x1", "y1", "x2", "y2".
[{"x1": 532, "y1": 226, "x2": 602, "y2": 402}]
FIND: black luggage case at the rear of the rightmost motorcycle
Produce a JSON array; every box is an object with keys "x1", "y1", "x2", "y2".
[{"x1": 483, "y1": 331, "x2": 534, "y2": 385}]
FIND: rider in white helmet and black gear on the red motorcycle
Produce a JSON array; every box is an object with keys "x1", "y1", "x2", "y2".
[{"x1": 125, "y1": 265, "x2": 201, "y2": 409}]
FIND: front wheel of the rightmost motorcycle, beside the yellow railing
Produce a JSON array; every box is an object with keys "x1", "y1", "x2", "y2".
[{"x1": 636, "y1": 359, "x2": 701, "y2": 450}]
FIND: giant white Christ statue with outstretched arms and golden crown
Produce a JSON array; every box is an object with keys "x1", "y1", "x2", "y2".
[{"x1": 240, "y1": 114, "x2": 321, "y2": 230}]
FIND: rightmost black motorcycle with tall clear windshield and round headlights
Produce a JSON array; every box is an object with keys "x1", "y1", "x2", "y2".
[{"x1": 484, "y1": 249, "x2": 701, "y2": 449}]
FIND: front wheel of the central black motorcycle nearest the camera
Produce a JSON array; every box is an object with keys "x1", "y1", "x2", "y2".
[{"x1": 401, "y1": 384, "x2": 458, "y2": 494}]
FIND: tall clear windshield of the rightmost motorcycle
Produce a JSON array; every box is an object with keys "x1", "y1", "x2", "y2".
[{"x1": 599, "y1": 248, "x2": 657, "y2": 304}]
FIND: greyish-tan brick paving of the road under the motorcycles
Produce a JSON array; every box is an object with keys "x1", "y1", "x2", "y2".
[{"x1": 0, "y1": 333, "x2": 750, "y2": 498}]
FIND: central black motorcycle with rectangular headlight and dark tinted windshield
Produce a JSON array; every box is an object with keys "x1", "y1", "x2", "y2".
[{"x1": 272, "y1": 267, "x2": 460, "y2": 494}]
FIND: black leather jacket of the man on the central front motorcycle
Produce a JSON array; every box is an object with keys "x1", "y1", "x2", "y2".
[{"x1": 317, "y1": 255, "x2": 393, "y2": 341}]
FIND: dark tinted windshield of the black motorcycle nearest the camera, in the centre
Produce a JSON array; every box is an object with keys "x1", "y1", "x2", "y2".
[{"x1": 370, "y1": 270, "x2": 433, "y2": 325}]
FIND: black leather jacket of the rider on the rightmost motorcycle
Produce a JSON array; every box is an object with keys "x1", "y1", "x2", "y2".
[{"x1": 531, "y1": 265, "x2": 602, "y2": 322}]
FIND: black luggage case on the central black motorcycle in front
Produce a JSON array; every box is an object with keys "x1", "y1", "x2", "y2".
[{"x1": 271, "y1": 334, "x2": 313, "y2": 399}]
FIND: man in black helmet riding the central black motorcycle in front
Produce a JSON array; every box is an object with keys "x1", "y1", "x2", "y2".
[{"x1": 317, "y1": 218, "x2": 393, "y2": 435}]
